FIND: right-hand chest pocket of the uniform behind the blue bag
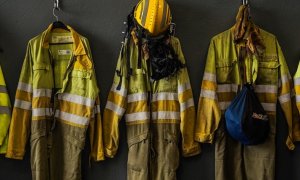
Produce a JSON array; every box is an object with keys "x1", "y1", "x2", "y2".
[{"x1": 256, "y1": 61, "x2": 280, "y2": 85}]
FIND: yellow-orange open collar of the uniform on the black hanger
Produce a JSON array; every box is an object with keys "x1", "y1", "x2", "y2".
[{"x1": 42, "y1": 24, "x2": 86, "y2": 56}]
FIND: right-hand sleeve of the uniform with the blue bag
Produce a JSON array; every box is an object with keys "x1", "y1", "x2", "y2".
[{"x1": 276, "y1": 42, "x2": 300, "y2": 150}]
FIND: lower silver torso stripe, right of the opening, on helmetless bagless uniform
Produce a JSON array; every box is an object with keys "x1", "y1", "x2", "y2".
[{"x1": 55, "y1": 111, "x2": 89, "y2": 125}]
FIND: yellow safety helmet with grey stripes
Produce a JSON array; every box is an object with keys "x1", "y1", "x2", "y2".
[{"x1": 134, "y1": 0, "x2": 172, "y2": 36}]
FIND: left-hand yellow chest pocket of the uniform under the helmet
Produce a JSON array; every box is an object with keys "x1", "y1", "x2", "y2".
[{"x1": 129, "y1": 69, "x2": 147, "y2": 93}]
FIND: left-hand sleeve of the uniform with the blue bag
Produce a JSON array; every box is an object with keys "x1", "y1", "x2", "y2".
[{"x1": 195, "y1": 41, "x2": 221, "y2": 143}]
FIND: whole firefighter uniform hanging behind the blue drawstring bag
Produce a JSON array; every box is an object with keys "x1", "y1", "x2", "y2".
[{"x1": 195, "y1": 27, "x2": 300, "y2": 180}]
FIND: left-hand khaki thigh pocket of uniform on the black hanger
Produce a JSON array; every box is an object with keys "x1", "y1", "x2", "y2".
[{"x1": 30, "y1": 129, "x2": 48, "y2": 173}]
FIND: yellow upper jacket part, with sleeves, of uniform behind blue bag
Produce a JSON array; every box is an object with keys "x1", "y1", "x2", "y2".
[{"x1": 195, "y1": 28, "x2": 300, "y2": 149}]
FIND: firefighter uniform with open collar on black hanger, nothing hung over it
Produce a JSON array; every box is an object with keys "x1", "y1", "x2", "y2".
[{"x1": 6, "y1": 24, "x2": 104, "y2": 180}]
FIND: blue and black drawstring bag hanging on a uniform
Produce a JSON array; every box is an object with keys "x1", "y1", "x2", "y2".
[{"x1": 225, "y1": 84, "x2": 270, "y2": 145}]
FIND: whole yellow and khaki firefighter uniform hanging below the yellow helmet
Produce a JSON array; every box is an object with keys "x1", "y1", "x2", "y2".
[{"x1": 103, "y1": 34, "x2": 200, "y2": 180}]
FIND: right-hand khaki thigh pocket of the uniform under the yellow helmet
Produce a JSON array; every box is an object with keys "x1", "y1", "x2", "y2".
[{"x1": 162, "y1": 130, "x2": 179, "y2": 172}]
